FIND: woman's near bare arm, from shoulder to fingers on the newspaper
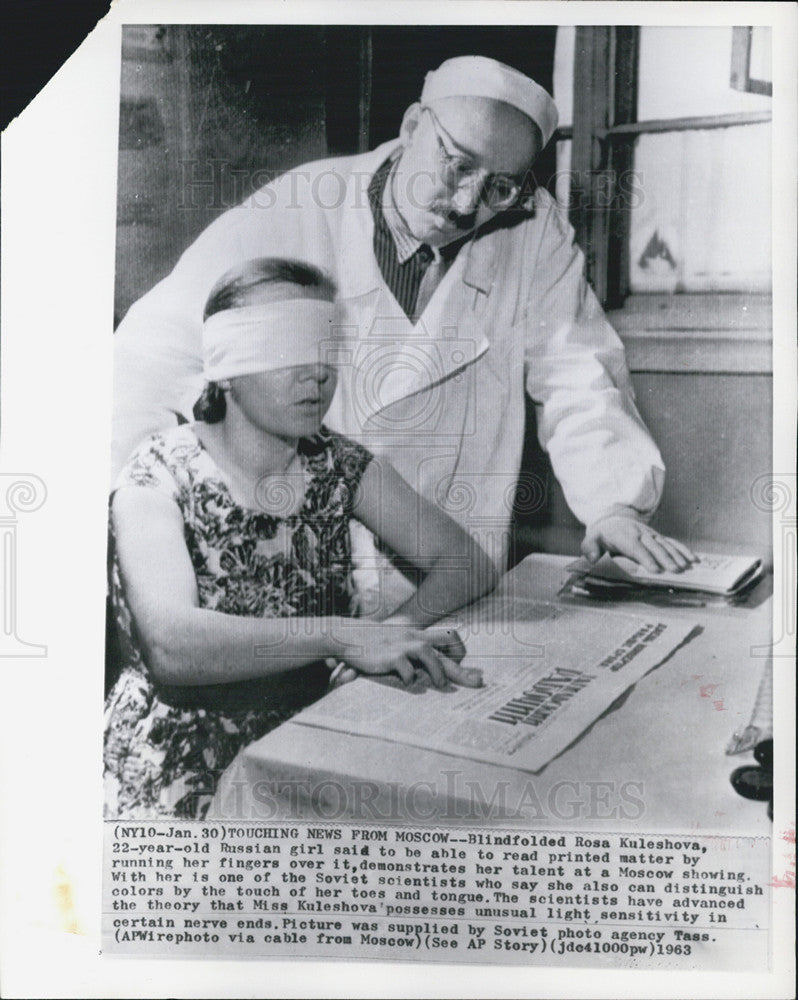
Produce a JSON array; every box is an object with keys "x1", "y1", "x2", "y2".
[{"x1": 111, "y1": 486, "x2": 479, "y2": 686}]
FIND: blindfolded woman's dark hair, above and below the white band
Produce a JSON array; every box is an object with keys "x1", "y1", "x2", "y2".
[{"x1": 194, "y1": 257, "x2": 337, "y2": 424}]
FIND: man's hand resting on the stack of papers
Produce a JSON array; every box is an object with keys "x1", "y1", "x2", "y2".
[{"x1": 582, "y1": 515, "x2": 698, "y2": 573}]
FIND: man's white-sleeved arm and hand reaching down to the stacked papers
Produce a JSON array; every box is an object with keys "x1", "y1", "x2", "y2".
[{"x1": 526, "y1": 195, "x2": 689, "y2": 569}]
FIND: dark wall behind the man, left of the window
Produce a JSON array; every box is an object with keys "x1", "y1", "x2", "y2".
[{"x1": 115, "y1": 25, "x2": 555, "y2": 322}]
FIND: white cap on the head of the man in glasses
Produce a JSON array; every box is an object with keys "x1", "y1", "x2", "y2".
[{"x1": 421, "y1": 56, "x2": 559, "y2": 146}]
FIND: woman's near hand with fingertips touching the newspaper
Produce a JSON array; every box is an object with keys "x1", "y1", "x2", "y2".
[{"x1": 341, "y1": 620, "x2": 482, "y2": 688}]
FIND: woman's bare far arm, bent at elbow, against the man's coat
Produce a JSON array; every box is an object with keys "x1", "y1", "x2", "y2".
[{"x1": 353, "y1": 459, "x2": 498, "y2": 626}]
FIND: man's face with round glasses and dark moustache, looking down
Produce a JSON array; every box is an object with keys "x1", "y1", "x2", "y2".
[{"x1": 394, "y1": 97, "x2": 541, "y2": 247}]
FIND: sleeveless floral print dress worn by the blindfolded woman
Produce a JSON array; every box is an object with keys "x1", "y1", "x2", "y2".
[{"x1": 104, "y1": 424, "x2": 371, "y2": 819}]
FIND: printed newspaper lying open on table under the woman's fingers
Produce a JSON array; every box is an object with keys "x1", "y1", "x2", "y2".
[{"x1": 293, "y1": 602, "x2": 696, "y2": 772}]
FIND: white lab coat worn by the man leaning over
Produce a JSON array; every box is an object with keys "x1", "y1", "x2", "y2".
[{"x1": 114, "y1": 143, "x2": 664, "y2": 580}]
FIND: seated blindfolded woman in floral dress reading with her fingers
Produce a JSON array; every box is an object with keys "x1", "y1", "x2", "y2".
[{"x1": 104, "y1": 258, "x2": 496, "y2": 819}]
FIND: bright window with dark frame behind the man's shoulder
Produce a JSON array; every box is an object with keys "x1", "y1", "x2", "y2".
[{"x1": 554, "y1": 26, "x2": 771, "y2": 370}]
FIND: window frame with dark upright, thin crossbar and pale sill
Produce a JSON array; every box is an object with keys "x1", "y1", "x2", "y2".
[{"x1": 554, "y1": 26, "x2": 772, "y2": 373}]
